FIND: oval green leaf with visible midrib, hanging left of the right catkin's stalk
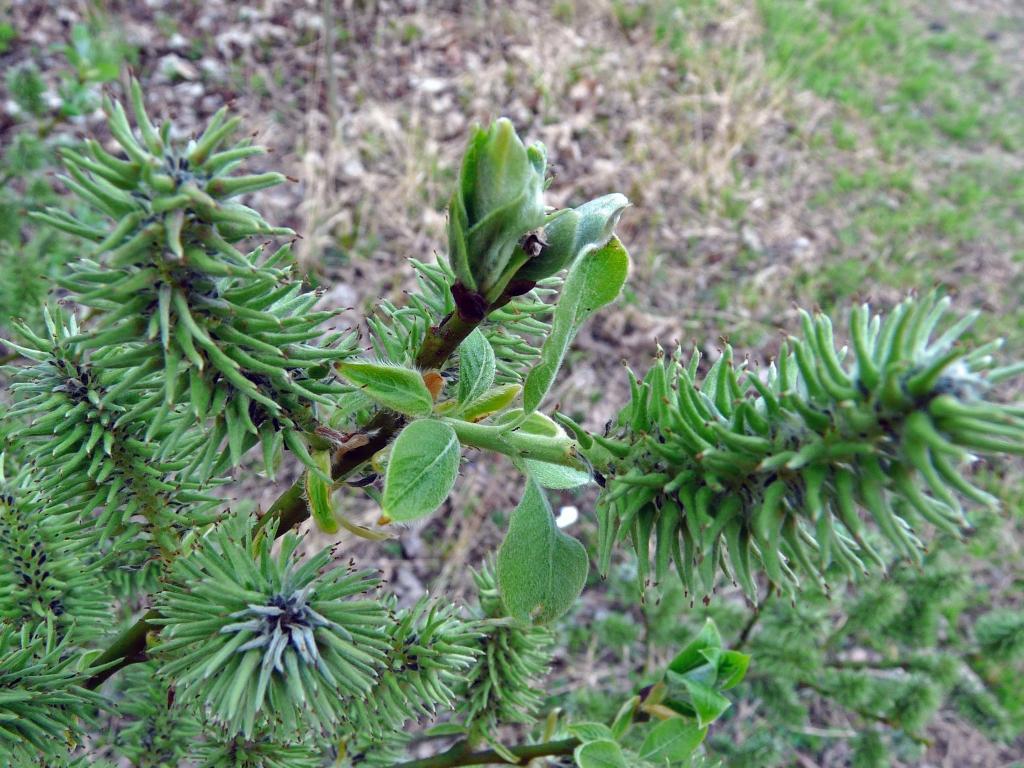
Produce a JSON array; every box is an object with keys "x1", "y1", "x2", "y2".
[{"x1": 381, "y1": 419, "x2": 461, "y2": 521}]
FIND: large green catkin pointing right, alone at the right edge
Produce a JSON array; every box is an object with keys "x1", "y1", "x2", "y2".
[{"x1": 593, "y1": 295, "x2": 1024, "y2": 599}]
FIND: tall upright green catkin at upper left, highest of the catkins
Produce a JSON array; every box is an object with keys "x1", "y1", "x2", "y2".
[{"x1": 33, "y1": 81, "x2": 355, "y2": 475}]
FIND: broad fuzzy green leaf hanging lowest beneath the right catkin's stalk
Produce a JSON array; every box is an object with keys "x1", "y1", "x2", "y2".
[{"x1": 498, "y1": 479, "x2": 590, "y2": 624}]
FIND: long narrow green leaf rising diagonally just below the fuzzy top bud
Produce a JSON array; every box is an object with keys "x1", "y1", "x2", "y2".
[{"x1": 522, "y1": 238, "x2": 630, "y2": 413}]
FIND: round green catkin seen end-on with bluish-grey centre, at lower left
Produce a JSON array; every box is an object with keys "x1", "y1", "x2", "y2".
[{"x1": 154, "y1": 518, "x2": 388, "y2": 738}]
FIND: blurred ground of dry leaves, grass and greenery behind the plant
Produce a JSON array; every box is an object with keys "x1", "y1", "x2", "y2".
[{"x1": 0, "y1": 0, "x2": 1024, "y2": 767}]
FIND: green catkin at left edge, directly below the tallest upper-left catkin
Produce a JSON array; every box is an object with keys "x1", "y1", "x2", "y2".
[{"x1": 9, "y1": 310, "x2": 219, "y2": 567}]
